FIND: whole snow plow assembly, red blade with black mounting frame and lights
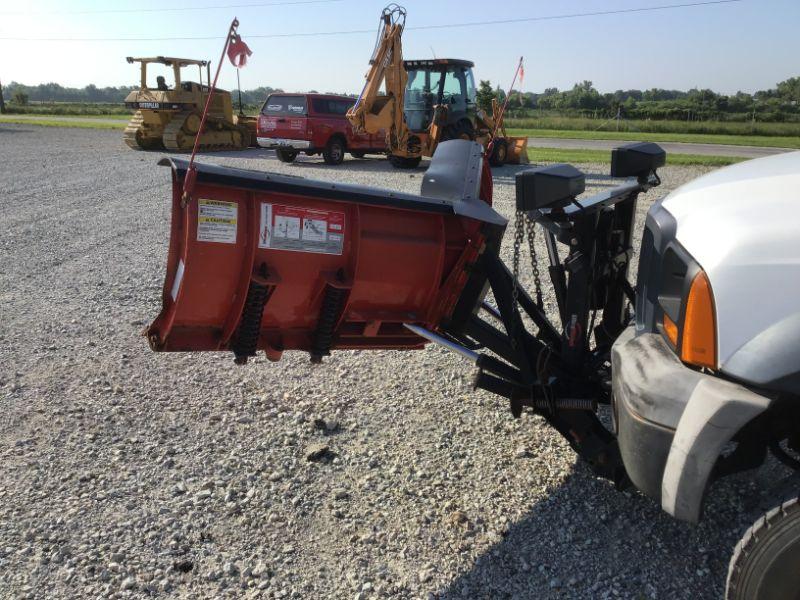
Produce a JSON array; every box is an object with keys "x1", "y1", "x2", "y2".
[{"x1": 146, "y1": 140, "x2": 666, "y2": 487}]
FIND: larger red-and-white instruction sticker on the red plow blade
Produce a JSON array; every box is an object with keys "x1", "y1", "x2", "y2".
[{"x1": 258, "y1": 202, "x2": 345, "y2": 254}]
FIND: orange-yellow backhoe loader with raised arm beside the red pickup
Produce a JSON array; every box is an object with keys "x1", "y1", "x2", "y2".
[{"x1": 347, "y1": 4, "x2": 528, "y2": 168}]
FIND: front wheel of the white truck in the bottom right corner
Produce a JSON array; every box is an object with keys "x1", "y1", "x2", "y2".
[{"x1": 725, "y1": 497, "x2": 800, "y2": 600}]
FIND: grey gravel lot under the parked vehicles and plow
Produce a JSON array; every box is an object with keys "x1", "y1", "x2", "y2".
[{"x1": 0, "y1": 125, "x2": 788, "y2": 599}]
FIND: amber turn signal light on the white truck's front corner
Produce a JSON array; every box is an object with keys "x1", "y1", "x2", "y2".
[{"x1": 680, "y1": 271, "x2": 717, "y2": 369}]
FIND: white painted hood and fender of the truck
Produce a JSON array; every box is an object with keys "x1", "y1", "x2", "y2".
[{"x1": 662, "y1": 152, "x2": 800, "y2": 375}]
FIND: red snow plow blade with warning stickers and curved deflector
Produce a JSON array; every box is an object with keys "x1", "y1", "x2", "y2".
[{"x1": 146, "y1": 140, "x2": 506, "y2": 363}]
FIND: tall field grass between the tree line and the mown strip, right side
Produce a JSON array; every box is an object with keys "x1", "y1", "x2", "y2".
[{"x1": 505, "y1": 116, "x2": 800, "y2": 137}]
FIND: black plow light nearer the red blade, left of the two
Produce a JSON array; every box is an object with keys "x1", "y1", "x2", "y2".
[{"x1": 516, "y1": 164, "x2": 586, "y2": 211}]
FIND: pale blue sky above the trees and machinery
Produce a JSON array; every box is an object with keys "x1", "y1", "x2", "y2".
[{"x1": 0, "y1": 0, "x2": 800, "y2": 93}]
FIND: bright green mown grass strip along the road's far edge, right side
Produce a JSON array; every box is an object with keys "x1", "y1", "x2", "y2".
[{"x1": 508, "y1": 129, "x2": 800, "y2": 148}]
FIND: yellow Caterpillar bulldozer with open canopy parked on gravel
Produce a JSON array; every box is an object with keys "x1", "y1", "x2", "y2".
[{"x1": 124, "y1": 56, "x2": 255, "y2": 152}]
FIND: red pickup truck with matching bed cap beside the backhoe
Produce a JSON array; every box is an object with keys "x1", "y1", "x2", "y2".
[{"x1": 258, "y1": 92, "x2": 387, "y2": 165}]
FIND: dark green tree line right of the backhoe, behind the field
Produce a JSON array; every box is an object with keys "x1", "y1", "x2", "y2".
[{"x1": 478, "y1": 77, "x2": 800, "y2": 122}]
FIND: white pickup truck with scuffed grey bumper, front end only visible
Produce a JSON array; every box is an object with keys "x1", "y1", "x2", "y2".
[{"x1": 612, "y1": 152, "x2": 800, "y2": 600}]
